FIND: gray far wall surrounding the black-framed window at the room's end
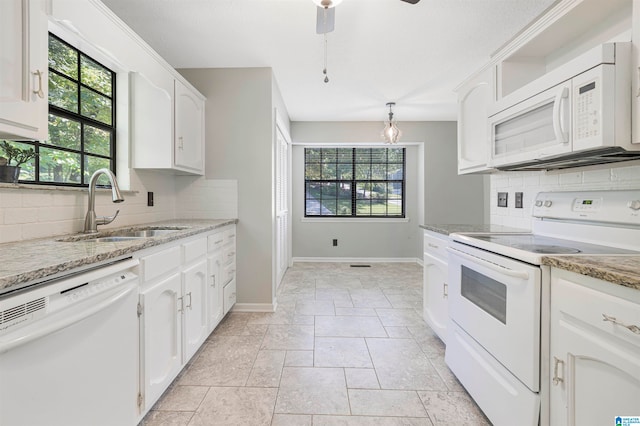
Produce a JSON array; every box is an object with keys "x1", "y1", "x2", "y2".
[{"x1": 291, "y1": 122, "x2": 486, "y2": 259}]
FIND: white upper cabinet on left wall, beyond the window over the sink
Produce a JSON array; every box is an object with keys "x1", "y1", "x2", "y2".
[{"x1": 130, "y1": 72, "x2": 204, "y2": 175}]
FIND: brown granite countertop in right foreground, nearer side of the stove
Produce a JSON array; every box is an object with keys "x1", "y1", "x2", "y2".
[{"x1": 542, "y1": 256, "x2": 640, "y2": 290}]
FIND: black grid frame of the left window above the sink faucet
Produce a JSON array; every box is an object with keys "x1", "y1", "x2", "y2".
[{"x1": 7, "y1": 32, "x2": 117, "y2": 187}]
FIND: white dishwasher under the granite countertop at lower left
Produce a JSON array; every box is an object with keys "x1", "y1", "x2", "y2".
[{"x1": 0, "y1": 259, "x2": 138, "y2": 426}]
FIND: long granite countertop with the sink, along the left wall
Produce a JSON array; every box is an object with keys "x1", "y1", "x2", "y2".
[{"x1": 0, "y1": 219, "x2": 238, "y2": 294}]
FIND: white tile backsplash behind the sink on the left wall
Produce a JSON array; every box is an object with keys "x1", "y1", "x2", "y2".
[{"x1": 0, "y1": 171, "x2": 238, "y2": 243}]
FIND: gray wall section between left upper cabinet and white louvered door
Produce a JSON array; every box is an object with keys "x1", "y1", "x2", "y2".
[{"x1": 177, "y1": 68, "x2": 288, "y2": 304}]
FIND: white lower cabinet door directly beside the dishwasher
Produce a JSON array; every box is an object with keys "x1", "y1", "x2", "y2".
[{"x1": 140, "y1": 273, "x2": 182, "y2": 407}]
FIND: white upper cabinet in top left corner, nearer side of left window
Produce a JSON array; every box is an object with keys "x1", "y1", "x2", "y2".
[{"x1": 0, "y1": 0, "x2": 48, "y2": 140}]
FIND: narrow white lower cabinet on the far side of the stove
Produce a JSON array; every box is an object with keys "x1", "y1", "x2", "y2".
[{"x1": 422, "y1": 231, "x2": 449, "y2": 343}]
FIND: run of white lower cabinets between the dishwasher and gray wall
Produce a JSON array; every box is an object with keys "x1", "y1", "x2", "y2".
[{"x1": 138, "y1": 225, "x2": 236, "y2": 419}]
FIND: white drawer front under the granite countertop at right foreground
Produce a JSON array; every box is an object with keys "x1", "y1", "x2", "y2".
[{"x1": 551, "y1": 277, "x2": 640, "y2": 347}]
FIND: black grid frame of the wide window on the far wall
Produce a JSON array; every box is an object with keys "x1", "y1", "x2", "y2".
[{"x1": 304, "y1": 146, "x2": 407, "y2": 219}]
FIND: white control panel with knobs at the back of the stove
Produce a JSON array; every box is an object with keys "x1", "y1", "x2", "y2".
[{"x1": 532, "y1": 190, "x2": 640, "y2": 226}]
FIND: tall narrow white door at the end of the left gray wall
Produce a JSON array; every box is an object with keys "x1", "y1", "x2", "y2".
[{"x1": 275, "y1": 119, "x2": 291, "y2": 287}]
